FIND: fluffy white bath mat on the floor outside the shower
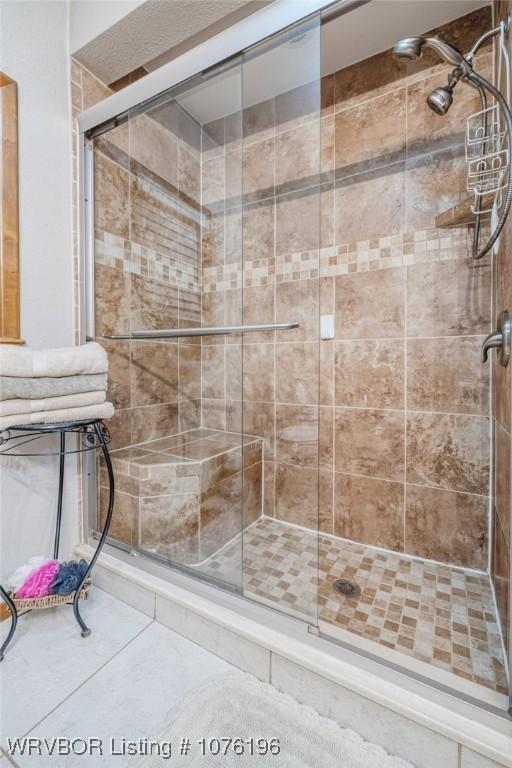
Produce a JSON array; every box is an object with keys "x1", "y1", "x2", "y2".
[{"x1": 137, "y1": 672, "x2": 412, "y2": 768}]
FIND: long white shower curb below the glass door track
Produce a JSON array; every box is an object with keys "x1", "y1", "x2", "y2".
[{"x1": 75, "y1": 544, "x2": 512, "y2": 768}]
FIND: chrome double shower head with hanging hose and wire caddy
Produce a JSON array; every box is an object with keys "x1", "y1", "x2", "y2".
[{"x1": 393, "y1": 20, "x2": 512, "y2": 259}]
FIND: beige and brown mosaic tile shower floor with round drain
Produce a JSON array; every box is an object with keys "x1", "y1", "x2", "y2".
[{"x1": 201, "y1": 517, "x2": 508, "y2": 694}]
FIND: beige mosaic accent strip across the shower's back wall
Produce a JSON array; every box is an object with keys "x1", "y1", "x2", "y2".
[{"x1": 203, "y1": 227, "x2": 485, "y2": 293}]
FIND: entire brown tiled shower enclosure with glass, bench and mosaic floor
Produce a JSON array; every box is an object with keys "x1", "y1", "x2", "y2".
[{"x1": 78, "y1": 2, "x2": 508, "y2": 709}]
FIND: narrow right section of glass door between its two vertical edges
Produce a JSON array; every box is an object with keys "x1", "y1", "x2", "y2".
[{"x1": 239, "y1": 16, "x2": 321, "y2": 623}]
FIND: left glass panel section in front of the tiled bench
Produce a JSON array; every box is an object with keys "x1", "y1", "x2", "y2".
[{"x1": 96, "y1": 62, "x2": 243, "y2": 589}]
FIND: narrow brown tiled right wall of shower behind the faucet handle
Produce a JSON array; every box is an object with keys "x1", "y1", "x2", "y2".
[{"x1": 491, "y1": 0, "x2": 512, "y2": 658}]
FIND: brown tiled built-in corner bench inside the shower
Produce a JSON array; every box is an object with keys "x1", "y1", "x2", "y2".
[{"x1": 99, "y1": 428, "x2": 263, "y2": 565}]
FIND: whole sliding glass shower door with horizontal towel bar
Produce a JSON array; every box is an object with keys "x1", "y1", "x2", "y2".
[{"x1": 94, "y1": 16, "x2": 320, "y2": 624}]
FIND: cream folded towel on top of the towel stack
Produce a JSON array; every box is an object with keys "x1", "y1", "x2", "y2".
[{"x1": 0, "y1": 342, "x2": 108, "y2": 377}]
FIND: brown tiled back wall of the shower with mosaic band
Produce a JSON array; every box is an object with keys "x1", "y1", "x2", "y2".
[{"x1": 202, "y1": 8, "x2": 492, "y2": 569}]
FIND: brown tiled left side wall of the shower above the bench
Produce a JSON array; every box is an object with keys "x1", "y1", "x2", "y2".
[{"x1": 72, "y1": 62, "x2": 201, "y2": 447}]
